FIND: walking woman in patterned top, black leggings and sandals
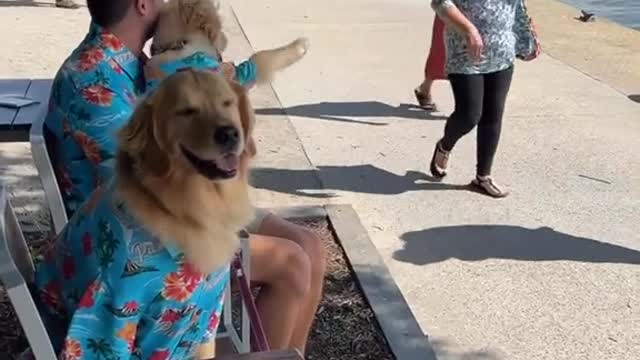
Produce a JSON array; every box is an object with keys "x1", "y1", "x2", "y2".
[{"x1": 430, "y1": 0, "x2": 539, "y2": 198}]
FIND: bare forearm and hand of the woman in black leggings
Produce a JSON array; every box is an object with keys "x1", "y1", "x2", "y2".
[{"x1": 431, "y1": 0, "x2": 484, "y2": 61}]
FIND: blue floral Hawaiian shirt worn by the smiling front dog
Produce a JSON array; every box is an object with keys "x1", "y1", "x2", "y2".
[{"x1": 34, "y1": 184, "x2": 229, "y2": 360}]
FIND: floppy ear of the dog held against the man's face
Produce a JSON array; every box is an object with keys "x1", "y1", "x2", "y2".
[{"x1": 179, "y1": 0, "x2": 227, "y2": 51}]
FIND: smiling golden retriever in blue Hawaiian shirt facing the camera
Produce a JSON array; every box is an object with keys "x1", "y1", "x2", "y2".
[{"x1": 34, "y1": 69, "x2": 254, "y2": 359}]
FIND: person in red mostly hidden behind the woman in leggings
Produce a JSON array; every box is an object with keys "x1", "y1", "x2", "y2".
[{"x1": 413, "y1": 16, "x2": 447, "y2": 111}]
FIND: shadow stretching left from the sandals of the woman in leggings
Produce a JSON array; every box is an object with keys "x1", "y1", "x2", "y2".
[{"x1": 251, "y1": 164, "x2": 472, "y2": 198}]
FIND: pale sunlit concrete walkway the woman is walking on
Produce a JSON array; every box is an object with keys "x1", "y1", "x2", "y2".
[{"x1": 230, "y1": 0, "x2": 640, "y2": 360}]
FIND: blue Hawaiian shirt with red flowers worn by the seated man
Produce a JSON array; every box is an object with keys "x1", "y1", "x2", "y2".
[{"x1": 45, "y1": 24, "x2": 144, "y2": 217}]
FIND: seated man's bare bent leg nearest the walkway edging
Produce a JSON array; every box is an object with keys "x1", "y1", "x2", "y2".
[{"x1": 250, "y1": 214, "x2": 327, "y2": 354}]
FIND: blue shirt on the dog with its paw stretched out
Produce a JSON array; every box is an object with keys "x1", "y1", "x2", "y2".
[{"x1": 145, "y1": 51, "x2": 257, "y2": 92}]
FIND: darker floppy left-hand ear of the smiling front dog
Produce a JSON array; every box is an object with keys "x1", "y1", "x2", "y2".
[{"x1": 118, "y1": 98, "x2": 170, "y2": 177}]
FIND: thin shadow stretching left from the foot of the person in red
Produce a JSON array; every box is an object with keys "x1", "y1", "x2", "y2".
[{"x1": 256, "y1": 101, "x2": 447, "y2": 126}]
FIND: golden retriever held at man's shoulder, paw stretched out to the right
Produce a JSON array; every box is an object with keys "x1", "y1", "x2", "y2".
[{"x1": 145, "y1": 0, "x2": 308, "y2": 88}]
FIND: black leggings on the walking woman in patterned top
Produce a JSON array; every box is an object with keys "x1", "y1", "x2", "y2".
[{"x1": 440, "y1": 67, "x2": 513, "y2": 176}]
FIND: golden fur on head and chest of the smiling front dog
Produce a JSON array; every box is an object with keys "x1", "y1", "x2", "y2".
[{"x1": 117, "y1": 70, "x2": 255, "y2": 272}]
